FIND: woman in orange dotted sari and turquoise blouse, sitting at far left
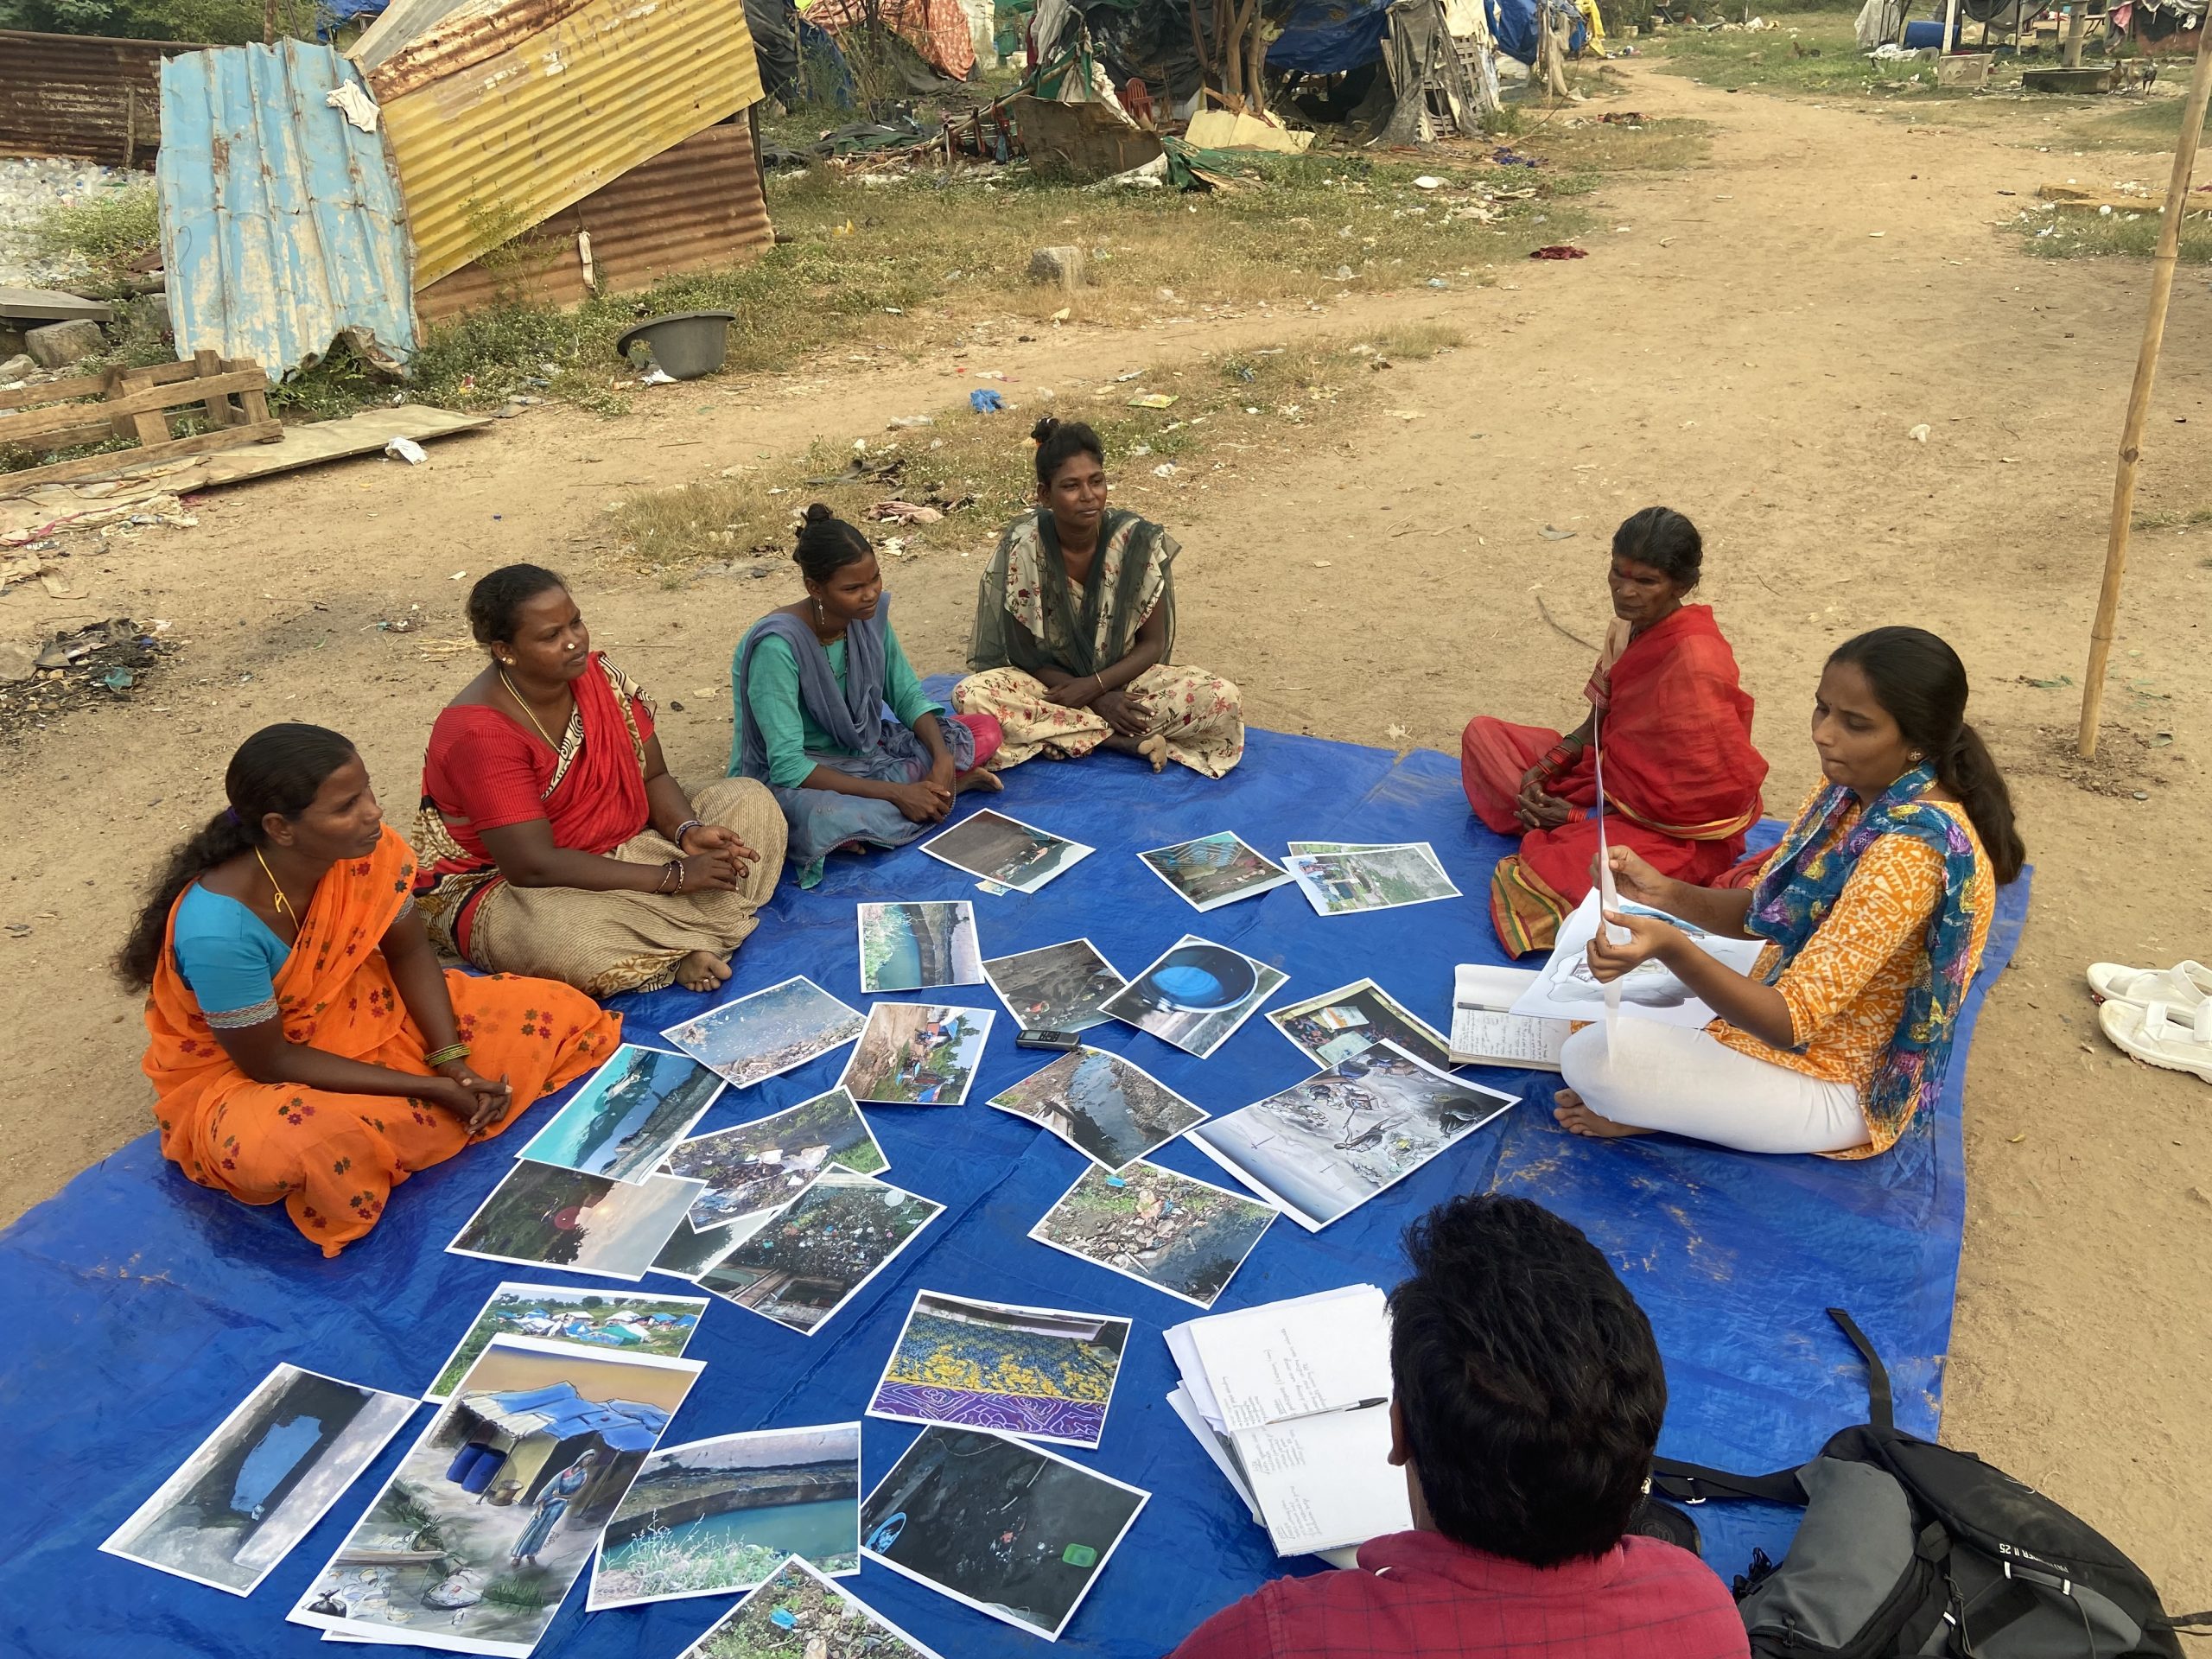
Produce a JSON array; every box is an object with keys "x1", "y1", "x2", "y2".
[{"x1": 118, "y1": 726, "x2": 621, "y2": 1256}]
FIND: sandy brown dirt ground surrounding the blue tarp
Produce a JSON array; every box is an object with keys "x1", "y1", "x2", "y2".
[{"x1": 0, "y1": 64, "x2": 2212, "y2": 1608}]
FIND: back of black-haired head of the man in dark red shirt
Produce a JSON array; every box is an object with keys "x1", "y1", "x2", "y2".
[{"x1": 1389, "y1": 1194, "x2": 1666, "y2": 1566}]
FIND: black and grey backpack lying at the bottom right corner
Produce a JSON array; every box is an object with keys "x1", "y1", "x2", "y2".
[{"x1": 1652, "y1": 1307, "x2": 2203, "y2": 1659}]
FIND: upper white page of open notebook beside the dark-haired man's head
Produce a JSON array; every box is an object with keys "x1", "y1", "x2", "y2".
[{"x1": 1190, "y1": 1285, "x2": 1391, "y2": 1431}]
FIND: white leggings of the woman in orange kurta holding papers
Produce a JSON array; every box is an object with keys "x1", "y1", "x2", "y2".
[{"x1": 1560, "y1": 1015, "x2": 1867, "y2": 1153}]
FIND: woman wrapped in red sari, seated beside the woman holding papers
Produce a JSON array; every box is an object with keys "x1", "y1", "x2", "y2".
[{"x1": 1460, "y1": 506, "x2": 1767, "y2": 956}]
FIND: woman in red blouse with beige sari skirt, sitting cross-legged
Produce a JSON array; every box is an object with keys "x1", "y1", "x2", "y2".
[{"x1": 416, "y1": 564, "x2": 783, "y2": 998}]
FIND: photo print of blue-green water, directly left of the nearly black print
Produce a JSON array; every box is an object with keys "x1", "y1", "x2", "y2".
[{"x1": 584, "y1": 1422, "x2": 861, "y2": 1612}]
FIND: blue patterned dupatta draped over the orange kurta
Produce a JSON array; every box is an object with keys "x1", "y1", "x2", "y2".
[{"x1": 1743, "y1": 763, "x2": 1975, "y2": 1146}]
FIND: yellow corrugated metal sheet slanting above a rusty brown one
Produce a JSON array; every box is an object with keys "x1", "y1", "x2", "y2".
[{"x1": 367, "y1": 0, "x2": 761, "y2": 288}]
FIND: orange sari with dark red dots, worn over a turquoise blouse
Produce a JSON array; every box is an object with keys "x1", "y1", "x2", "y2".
[{"x1": 143, "y1": 827, "x2": 621, "y2": 1256}]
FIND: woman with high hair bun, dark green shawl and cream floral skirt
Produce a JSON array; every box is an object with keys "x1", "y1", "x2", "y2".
[{"x1": 953, "y1": 418, "x2": 1243, "y2": 779}]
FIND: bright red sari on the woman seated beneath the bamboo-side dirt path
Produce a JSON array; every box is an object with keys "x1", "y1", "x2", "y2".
[{"x1": 1460, "y1": 604, "x2": 1767, "y2": 956}]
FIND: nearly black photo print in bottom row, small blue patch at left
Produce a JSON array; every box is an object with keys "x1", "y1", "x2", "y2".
[{"x1": 861, "y1": 1427, "x2": 1148, "y2": 1642}]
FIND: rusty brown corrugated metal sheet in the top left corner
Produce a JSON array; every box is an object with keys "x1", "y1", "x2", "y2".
[{"x1": 0, "y1": 29, "x2": 201, "y2": 168}]
